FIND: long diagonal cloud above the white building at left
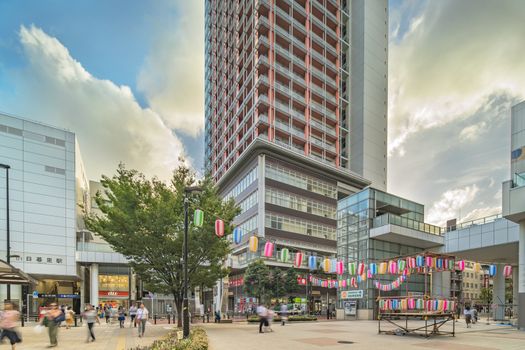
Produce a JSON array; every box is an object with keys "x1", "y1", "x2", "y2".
[{"x1": 10, "y1": 26, "x2": 188, "y2": 179}]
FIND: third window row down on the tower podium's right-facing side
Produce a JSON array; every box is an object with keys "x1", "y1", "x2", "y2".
[{"x1": 265, "y1": 213, "x2": 335, "y2": 240}]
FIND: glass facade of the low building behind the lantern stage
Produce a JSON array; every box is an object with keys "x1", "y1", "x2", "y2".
[{"x1": 337, "y1": 188, "x2": 428, "y2": 309}]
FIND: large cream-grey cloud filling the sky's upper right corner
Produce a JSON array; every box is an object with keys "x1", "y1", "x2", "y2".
[{"x1": 389, "y1": 0, "x2": 525, "y2": 156}]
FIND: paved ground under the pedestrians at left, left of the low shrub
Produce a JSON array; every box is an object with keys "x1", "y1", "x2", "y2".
[{"x1": 14, "y1": 322, "x2": 172, "y2": 350}]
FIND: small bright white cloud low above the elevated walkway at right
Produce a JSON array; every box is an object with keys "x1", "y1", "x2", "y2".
[{"x1": 426, "y1": 185, "x2": 479, "y2": 226}]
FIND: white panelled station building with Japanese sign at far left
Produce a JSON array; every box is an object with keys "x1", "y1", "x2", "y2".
[{"x1": 0, "y1": 114, "x2": 89, "y2": 311}]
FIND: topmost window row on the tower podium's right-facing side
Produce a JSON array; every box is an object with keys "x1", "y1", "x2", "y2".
[{"x1": 266, "y1": 163, "x2": 337, "y2": 198}]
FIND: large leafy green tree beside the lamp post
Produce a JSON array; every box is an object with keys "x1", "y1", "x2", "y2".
[{"x1": 86, "y1": 164, "x2": 239, "y2": 326}]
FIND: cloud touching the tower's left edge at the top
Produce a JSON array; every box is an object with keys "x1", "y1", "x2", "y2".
[{"x1": 138, "y1": 0, "x2": 204, "y2": 137}]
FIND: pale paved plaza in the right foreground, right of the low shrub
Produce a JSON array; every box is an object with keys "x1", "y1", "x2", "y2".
[{"x1": 205, "y1": 321, "x2": 525, "y2": 350}]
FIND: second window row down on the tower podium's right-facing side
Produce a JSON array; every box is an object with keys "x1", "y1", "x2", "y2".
[{"x1": 265, "y1": 188, "x2": 336, "y2": 219}]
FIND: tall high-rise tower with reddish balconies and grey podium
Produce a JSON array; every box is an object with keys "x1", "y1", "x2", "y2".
[{"x1": 205, "y1": 0, "x2": 388, "y2": 309}]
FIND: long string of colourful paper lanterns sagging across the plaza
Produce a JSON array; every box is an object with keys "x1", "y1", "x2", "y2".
[{"x1": 193, "y1": 209, "x2": 512, "y2": 282}]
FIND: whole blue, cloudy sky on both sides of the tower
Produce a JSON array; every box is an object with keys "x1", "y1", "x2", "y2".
[{"x1": 0, "y1": 0, "x2": 525, "y2": 225}]
